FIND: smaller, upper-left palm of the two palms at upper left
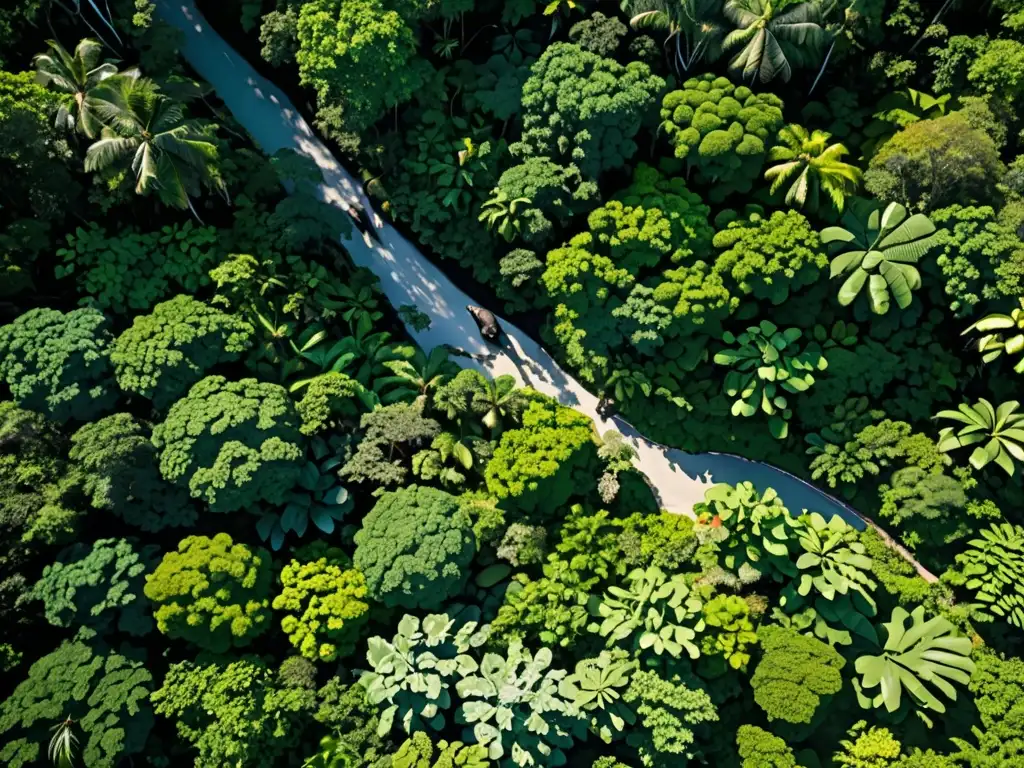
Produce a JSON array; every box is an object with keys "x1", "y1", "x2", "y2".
[{"x1": 32, "y1": 38, "x2": 118, "y2": 138}]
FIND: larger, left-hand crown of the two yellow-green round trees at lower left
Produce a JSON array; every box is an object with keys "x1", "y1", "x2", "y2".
[{"x1": 145, "y1": 534, "x2": 271, "y2": 653}]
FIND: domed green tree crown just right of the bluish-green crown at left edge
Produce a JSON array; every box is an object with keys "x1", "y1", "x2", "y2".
[{"x1": 111, "y1": 294, "x2": 253, "y2": 410}]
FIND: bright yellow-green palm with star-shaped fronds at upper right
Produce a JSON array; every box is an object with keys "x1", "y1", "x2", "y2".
[{"x1": 765, "y1": 125, "x2": 861, "y2": 213}]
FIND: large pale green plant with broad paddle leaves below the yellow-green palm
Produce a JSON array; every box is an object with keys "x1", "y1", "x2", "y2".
[{"x1": 821, "y1": 201, "x2": 935, "y2": 314}]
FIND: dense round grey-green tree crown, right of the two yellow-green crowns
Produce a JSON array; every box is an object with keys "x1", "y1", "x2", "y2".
[{"x1": 353, "y1": 485, "x2": 476, "y2": 610}]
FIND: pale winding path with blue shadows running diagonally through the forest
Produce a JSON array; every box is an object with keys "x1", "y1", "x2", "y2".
[{"x1": 157, "y1": 0, "x2": 936, "y2": 582}]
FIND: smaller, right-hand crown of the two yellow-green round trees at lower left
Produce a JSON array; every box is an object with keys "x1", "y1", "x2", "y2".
[{"x1": 273, "y1": 542, "x2": 370, "y2": 662}]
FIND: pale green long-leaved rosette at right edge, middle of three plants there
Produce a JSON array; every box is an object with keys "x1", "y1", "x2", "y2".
[{"x1": 935, "y1": 397, "x2": 1024, "y2": 475}]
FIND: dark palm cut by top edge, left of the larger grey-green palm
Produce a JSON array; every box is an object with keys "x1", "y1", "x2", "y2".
[{"x1": 627, "y1": 0, "x2": 725, "y2": 72}]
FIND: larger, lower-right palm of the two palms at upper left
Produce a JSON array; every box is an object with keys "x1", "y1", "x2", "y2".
[{"x1": 85, "y1": 75, "x2": 222, "y2": 219}]
